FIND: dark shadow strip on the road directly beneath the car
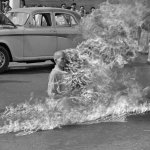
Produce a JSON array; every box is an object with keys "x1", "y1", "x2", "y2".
[{"x1": 2, "y1": 64, "x2": 54, "y2": 75}]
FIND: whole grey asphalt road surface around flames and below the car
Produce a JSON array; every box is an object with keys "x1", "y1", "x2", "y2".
[{"x1": 0, "y1": 56, "x2": 150, "y2": 150}]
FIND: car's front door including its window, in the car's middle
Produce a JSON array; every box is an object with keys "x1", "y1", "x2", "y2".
[{"x1": 24, "y1": 12, "x2": 57, "y2": 59}]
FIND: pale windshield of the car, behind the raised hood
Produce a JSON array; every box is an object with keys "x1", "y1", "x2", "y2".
[{"x1": 6, "y1": 12, "x2": 29, "y2": 26}]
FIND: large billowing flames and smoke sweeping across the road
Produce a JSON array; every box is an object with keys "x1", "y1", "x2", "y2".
[{"x1": 0, "y1": 3, "x2": 150, "y2": 135}]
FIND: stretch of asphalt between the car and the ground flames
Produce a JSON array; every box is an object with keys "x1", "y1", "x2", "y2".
[{"x1": 0, "y1": 61, "x2": 53, "y2": 109}]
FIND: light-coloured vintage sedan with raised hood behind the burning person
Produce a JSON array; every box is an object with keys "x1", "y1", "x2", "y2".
[{"x1": 0, "y1": 7, "x2": 82, "y2": 73}]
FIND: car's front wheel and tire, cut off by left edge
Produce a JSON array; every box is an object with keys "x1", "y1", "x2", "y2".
[{"x1": 0, "y1": 46, "x2": 9, "y2": 73}]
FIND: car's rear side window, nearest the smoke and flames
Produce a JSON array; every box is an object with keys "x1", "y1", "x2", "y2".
[{"x1": 55, "y1": 13, "x2": 77, "y2": 27}]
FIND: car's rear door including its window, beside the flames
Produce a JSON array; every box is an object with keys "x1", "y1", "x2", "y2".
[{"x1": 54, "y1": 12, "x2": 82, "y2": 50}]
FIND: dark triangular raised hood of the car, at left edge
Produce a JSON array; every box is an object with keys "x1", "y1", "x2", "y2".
[{"x1": 0, "y1": 12, "x2": 16, "y2": 29}]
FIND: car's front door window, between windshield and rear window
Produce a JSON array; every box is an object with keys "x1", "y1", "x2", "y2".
[{"x1": 33, "y1": 13, "x2": 52, "y2": 27}]
